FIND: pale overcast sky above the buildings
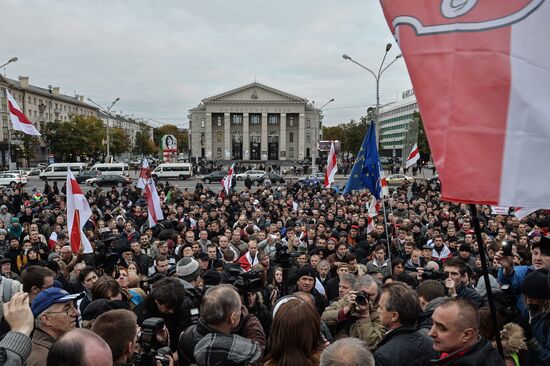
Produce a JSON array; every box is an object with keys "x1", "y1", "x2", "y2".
[{"x1": 0, "y1": 0, "x2": 411, "y2": 127}]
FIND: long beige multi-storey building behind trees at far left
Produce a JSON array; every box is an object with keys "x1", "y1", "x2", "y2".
[{"x1": 0, "y1": 75, "x2": 98, "y2": 166}]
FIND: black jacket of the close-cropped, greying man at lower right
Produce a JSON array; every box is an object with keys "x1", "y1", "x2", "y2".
[{"x1": 432, "y1": 338, "x2": 505, "y2": 366}]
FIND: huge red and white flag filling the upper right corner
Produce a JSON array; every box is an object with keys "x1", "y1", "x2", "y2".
[{"x1": 380, "y1": 0, "x2": 550, "y2": 207}]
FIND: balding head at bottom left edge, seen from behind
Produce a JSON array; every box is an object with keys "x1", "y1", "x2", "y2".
[{"x1": 47, "y1": 329, "x2": 113, "y2": 366}]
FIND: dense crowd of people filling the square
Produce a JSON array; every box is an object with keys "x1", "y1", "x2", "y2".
[{"x1": 0, "y1": 174, "x2": 550, "y2": 366}]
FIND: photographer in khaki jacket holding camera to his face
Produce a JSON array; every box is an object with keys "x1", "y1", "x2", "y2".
[{"x1": 321, "y1": 275, "x2": 386, "y2": 350}]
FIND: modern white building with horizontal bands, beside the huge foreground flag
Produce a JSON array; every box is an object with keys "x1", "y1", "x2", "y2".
[{"x1": 378, "y1": 89, "x2": 419, "y2": 159}]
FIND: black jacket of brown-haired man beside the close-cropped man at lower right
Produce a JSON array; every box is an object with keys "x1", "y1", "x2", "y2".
[{"x1": 374, "y1": 327, "x2": 437, "y2": 366}]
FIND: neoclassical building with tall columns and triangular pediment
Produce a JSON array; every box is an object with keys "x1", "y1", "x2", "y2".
[{"x1": 189, "y1": 82, "x2": 321, "y2": 161}]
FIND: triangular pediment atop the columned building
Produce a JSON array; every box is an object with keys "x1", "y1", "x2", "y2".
[{"x1": 202, "y1": 82, "x2": 307, "y2": 104}]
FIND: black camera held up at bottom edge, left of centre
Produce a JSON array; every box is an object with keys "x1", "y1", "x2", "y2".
[{"x1": 134, "y1": 318, "x2": 171, "y2": 366}]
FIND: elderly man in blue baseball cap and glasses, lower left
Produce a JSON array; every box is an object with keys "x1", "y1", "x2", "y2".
[{"x1": 27, "y1": 287, "x2": 82, "y2": 366}]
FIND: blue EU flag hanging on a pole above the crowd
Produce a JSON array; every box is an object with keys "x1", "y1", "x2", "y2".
[{"x1": 342, "y1": 122, "x2": 382, "y2": 199}]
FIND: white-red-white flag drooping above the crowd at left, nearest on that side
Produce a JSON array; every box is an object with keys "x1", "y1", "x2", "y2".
[{"x1": 66, "y1": 168, "x2": 93, "y2": 253}]
